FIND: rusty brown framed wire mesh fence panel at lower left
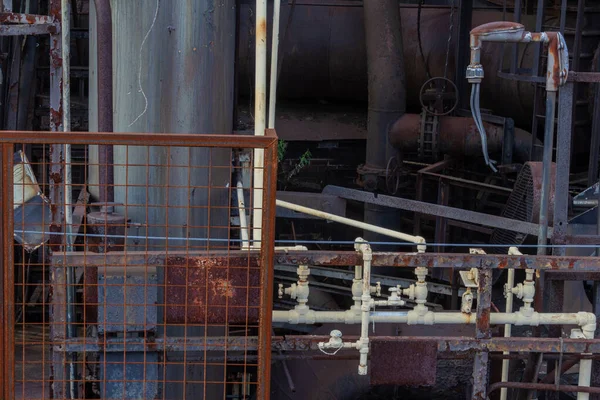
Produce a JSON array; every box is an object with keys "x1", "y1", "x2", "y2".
[{"x1": 0, "y1": 131, "x2": 277, "y2": 399}]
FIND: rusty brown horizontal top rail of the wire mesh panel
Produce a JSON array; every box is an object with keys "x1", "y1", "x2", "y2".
[{"x1": 0, "y1": 130, "x2": 277, "y2": 149}]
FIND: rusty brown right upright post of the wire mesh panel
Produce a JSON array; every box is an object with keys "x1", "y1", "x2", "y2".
[{"x1": 257, "y1": 138, "x2": 277, "y2": 400}]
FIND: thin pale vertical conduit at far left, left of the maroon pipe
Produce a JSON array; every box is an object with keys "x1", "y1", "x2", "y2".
[{"x1": 60, "y1": 0, "x2": 78, "y2": 399}]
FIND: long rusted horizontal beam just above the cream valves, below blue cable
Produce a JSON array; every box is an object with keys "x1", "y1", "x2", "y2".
[{"x1": 53, "y1": 250, "x2": 600, "y2": 273}]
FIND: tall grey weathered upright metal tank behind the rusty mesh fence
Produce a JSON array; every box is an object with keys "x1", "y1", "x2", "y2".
[{"x1": 88, "y1": 0, "x2": 236, "y2": 399}]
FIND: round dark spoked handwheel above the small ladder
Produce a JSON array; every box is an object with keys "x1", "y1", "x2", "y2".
[{"x1": 419, "y1": 77, "x2": 458, "y2": 116}]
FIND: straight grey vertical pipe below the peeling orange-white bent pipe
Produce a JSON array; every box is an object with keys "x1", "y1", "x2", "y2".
[{"x1": 537, "y1": 92, "x2": 556, "y2": 255}]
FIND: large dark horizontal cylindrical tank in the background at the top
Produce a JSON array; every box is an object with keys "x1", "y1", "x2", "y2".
[{"x1": 237, "y1": 2, "x2": 535, "y2": 128}]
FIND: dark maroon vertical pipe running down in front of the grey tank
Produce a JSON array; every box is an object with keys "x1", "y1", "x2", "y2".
[{"x1": 94, "y1": 0, "x2": 115, "y2": 203}]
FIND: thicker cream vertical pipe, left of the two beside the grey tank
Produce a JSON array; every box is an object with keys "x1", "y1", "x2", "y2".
[{"x1": 252, "y1": 0, "x2": 267, "y2": 247}]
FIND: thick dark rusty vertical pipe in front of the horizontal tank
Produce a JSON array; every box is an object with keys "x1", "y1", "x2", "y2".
[{"x1": 363, "y1": 0, "x2": 406, "y2": 241}]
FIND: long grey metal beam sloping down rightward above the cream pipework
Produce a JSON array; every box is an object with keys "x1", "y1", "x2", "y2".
[{"x1": 323, "y1": 185, "x2": 552, "y2": 236}]
